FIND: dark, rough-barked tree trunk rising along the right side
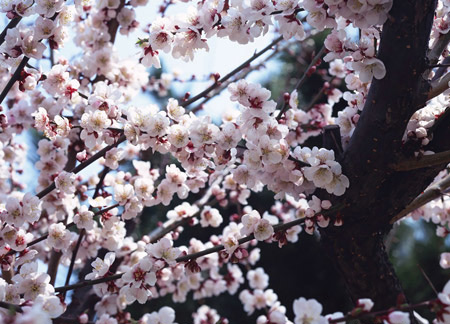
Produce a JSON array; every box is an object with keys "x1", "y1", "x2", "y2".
[{"x1": 321, "y1": 0, "x2": 442, "y2": 316}]
